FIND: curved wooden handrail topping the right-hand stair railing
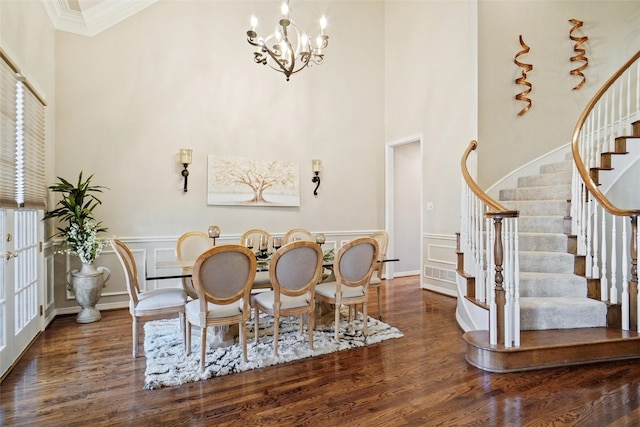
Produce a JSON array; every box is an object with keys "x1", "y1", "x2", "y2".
[{"x1": 571, "y1": 50, "x2": 640, "y2": 216}]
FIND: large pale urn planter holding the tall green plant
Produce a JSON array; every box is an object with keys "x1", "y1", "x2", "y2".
[{"x1": 67, "y1": 264, "x2": 111, "y2": 323}]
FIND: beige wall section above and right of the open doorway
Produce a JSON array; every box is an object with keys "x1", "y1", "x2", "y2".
[{"x1": 384, "y1": 1, "x2": 477, "y2": 293}]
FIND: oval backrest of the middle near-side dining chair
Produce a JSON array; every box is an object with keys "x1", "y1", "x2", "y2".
[{"x1": 269, "y1": 240, "x2": 322, "y2": 296}]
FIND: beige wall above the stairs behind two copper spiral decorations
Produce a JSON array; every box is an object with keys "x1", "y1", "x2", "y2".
[{"x1": 478, "y1": 0, "x2": 640, "y2": 188}]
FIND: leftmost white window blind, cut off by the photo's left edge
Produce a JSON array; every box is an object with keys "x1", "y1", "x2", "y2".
[{"x1": 0, "y1": 52, "x2": 18, "y2": 208}]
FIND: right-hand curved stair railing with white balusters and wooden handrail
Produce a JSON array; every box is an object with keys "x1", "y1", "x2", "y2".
[{"x1": 571, "y1": 51, "x2": 640, "y2": 331}]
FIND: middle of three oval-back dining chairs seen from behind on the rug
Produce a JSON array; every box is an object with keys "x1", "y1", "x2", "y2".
[{"x1": 253, "y1": 240, "x2": 322, "y2": 356}]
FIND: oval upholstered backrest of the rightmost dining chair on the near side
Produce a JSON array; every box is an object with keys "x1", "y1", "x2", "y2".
[{"x1": 333, "y1": 237, "x2": 378, "y2": 286}]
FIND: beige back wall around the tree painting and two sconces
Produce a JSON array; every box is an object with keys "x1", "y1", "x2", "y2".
[{"x1": 56, "y1": 1, "x2": 384, "y2": 241}]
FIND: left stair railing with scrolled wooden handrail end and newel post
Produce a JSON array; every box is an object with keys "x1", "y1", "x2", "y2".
[{"x1": 457, "y1": 141, "x2": 520, "y2": 347}]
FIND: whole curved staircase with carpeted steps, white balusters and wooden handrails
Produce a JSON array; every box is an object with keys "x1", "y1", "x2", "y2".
[{"x1": 457, "y1": 51, "x2": 640, "y2": 372}]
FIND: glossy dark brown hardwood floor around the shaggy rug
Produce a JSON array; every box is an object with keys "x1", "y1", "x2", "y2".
[{"x1": 0, "y1": 277, "x2": 640, "y2": 427}]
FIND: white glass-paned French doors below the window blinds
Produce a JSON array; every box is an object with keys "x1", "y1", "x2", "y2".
[{"x1": 0, "y1": 209, "x2": 42, "y2": 375}]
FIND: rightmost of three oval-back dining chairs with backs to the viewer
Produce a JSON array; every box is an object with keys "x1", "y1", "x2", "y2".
[{"x1": 316, "y1": 237, "x2": 378, "y2": 341}]
